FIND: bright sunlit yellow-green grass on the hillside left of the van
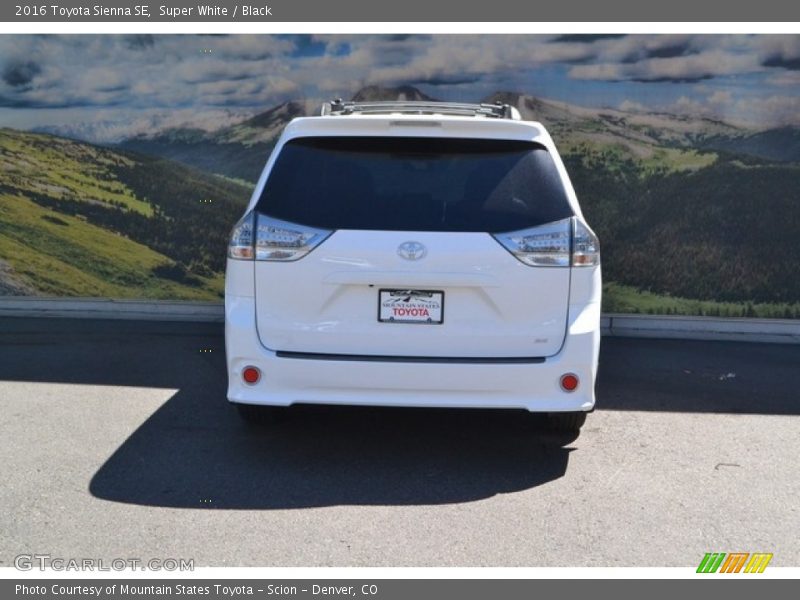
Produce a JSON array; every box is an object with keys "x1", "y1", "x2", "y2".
[{"x1": 0, "y1": 129, "x2": 224, "y2": 301}]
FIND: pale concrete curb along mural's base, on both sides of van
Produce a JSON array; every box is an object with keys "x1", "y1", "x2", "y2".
[{"x1": 0, "y1": 296, "x2": 800, "y2": 344}]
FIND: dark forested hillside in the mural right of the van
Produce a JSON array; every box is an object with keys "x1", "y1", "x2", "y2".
[{"x1": 566, "y1": 153, "x2": 800, "y2": 317}]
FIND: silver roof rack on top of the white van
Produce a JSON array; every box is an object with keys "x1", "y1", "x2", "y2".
[{"x1": 320, "y1": 98, "x2": 520, "y2": 120}]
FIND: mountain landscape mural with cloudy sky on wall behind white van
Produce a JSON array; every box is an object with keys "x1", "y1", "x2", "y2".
[{"x1": 0, "y1": 35, "x2": 800, "y2": 318}]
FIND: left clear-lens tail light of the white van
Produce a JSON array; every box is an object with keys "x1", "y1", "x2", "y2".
[{"x1": 228, "y1": 212, "x2": 331, "y2": 262}]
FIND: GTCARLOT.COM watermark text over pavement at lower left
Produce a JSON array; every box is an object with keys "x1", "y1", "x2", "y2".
[{"x1": 14, "y1": 554, "x2": 194, "y2": 571}]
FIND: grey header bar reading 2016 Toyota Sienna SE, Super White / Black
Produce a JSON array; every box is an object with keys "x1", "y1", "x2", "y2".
[{"x1": 0, "y1": 0, "x2": 800, "y2": 23}]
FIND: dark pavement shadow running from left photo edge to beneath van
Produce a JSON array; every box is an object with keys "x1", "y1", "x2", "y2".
[{"x1": 0, "y1": 320, "x2": 575, "y2": 510}]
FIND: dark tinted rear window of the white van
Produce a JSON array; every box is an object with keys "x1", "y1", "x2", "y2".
[{"x1": 257, "y1": 137, "x2": 573, "y2": 233}]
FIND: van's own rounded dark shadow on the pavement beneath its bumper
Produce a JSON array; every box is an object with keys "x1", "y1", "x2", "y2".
[{"x1": 89, "y1": 396, "x2": 570, "y2": 509}]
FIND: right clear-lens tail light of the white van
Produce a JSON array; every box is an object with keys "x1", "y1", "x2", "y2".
[{"x1": 494, "y1": 217, "x2": 600, "y2": 267}]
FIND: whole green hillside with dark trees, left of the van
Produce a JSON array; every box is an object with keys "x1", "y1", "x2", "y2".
[{"x1": 0, "y1": 129, "x2": 249, "y2": 300}]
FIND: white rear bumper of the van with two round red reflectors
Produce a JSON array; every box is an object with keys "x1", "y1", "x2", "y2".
[{"x1": 225, "y1": 296, "x2": 600, "y2": 412}]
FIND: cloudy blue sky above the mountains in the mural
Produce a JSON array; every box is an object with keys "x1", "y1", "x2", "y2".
[{"x1": 0, "y1": 34, "x2": 800, "y2": 142}]
